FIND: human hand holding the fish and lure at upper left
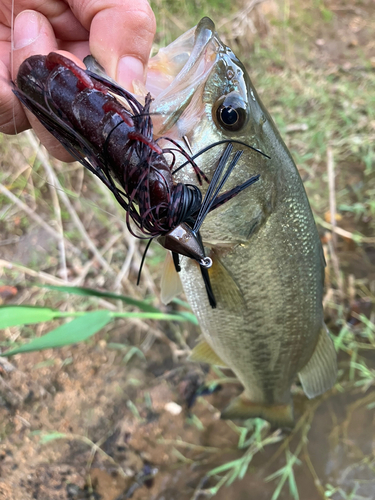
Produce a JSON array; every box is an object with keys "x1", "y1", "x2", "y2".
[{"x1": 0, "y1": 0, "x2": 156, "y2": 161}]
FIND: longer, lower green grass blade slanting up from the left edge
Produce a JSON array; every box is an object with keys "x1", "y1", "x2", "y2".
[{"x1": 2, "y1": 310, "x2": 111, "y2": 356}]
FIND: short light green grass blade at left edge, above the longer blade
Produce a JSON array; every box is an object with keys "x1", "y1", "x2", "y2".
[{"x1": 0, "y1": 306, "x2": 56, "y2": 329}]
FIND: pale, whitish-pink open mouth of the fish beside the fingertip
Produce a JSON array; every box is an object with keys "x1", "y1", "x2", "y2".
[{"x1": 146, "y1": 17, "x2": 222, "y2": 139}]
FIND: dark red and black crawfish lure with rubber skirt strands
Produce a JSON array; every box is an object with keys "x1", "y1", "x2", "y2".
[{"x1": 13, "y1": 52, "x2": 259, "y2": 307}]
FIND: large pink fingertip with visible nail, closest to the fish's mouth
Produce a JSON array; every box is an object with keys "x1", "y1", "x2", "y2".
[{"x1": 70, "y1": 0, "x2": 156, "y2": 90}]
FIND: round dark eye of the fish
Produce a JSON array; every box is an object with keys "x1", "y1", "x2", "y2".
[{"x1": 213, "y1": 92, "x2": 247, "y2": 132}]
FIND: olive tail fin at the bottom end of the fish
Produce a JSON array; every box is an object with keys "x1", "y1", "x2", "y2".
[{"x1": 221, "y1": 394, "x2": 294, "y2": 429}]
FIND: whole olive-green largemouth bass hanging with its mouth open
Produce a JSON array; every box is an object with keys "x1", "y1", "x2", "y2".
[{"x1": 150, "y1": 18, "x2": 337, "y2": 427}]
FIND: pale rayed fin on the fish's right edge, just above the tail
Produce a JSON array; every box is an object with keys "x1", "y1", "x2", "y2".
[{"x1": 298, "y1": 325, "x2": 337, "y2": 399}]
